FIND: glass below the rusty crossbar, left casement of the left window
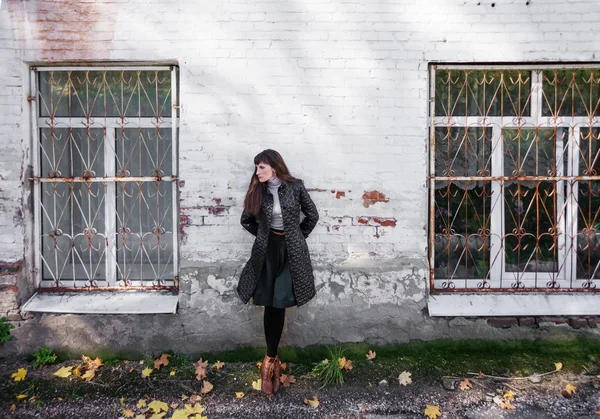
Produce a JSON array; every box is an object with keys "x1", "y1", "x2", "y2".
[{"x1": 41, "y1": 182, "x2": 106, "y2": 286}]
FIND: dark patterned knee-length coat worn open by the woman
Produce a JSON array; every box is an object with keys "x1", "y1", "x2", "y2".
[{"x1": 237, "y1": 179, "x2": 319, "y2": 306}]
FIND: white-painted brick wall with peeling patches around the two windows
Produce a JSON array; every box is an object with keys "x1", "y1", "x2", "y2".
[{"x1": 0, "y1": 0, "x2": 600, "y2": 354}]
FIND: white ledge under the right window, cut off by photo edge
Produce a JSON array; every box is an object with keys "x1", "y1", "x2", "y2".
[{"x1": 427, "y1": 293, "x2": 600, "y2": 317}]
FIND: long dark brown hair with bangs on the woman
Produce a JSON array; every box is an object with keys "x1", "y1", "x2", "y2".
[{"x1": 244, "y1": 149, "x2": 296, "y2": 217}]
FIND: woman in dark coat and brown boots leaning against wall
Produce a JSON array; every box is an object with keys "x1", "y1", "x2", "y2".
[{"x1": 237, "y1": 150, "x2": 319, "y2": 395}]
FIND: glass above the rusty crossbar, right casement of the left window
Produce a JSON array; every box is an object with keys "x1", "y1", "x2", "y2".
[{"x1": 117, "y1": 128, "x2": 173, "y2": 176}]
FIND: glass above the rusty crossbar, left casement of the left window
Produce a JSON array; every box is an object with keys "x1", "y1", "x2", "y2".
[{"x1": 40, "y1": 128, "x2": 105, "y2": 178}]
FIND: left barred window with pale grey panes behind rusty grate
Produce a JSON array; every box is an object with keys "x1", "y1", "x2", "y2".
[{"x1": 31, "y1": 66, "x2": 178, "y2": 289}]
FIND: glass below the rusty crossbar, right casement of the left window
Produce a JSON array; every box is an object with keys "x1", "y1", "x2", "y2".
[{"x1": 117, "y1": 182, "x2": 173, "y2": 285}]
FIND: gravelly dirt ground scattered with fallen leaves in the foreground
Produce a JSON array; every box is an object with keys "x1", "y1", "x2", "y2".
[{"x1": 0, "y1": 358, "x2": 600, "y2": 419}]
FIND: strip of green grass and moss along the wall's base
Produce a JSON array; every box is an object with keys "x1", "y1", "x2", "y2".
[{"x1": 203, "y1": 338, "x2": 600, "y2": 377}]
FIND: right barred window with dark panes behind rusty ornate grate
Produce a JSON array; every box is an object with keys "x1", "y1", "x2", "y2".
[{"x1": 429, "y1": 65, "x2": 600, "y2": 292}]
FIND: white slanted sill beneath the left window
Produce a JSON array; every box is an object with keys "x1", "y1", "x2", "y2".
[{"x1": 21, "y1": 291, "x2": 179, "y2": 314}]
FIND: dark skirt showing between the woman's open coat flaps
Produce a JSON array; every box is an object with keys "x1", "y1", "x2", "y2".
[{"x1": 252, "y1": 231, "x2": 297, "y2": 308}]
